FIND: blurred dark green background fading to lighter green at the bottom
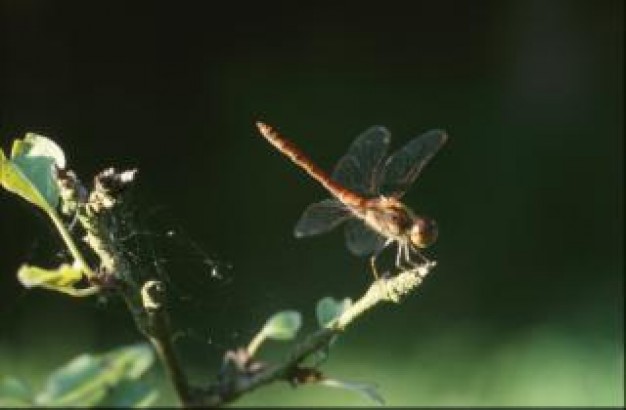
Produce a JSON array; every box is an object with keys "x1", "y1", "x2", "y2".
[{"x1": 0, "y1": 0, "x2": 624, "y2": 406}]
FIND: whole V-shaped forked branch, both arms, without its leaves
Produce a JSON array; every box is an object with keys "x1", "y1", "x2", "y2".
[{"x1": 58, "y1": 163, "x2": 435, "y2": 407}]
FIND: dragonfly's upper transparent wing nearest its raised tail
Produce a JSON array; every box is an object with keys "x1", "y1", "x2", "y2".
[{"x1": 332, "y1": 126, "x2": 391, "y2": 195}]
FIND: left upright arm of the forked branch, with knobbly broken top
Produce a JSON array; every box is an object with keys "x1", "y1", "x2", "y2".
[{"x1": 59, "y1": 168, "x2": 193, "y2": 407}]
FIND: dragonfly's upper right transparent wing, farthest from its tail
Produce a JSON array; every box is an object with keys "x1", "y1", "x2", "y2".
[{"x1": 379, "y1": 130, "x2": 448, "y2": 198}]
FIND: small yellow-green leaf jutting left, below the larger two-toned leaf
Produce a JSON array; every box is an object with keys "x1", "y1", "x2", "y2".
[{"x1": 17, "y1": 263, "x2": 97, "y2": 296}]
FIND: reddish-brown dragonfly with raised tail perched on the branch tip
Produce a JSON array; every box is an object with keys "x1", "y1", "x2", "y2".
[{"x1": 256, "y1": 122, "x2": 448, "y2": 279}]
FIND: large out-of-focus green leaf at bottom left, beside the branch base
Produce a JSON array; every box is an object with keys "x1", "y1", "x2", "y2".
[{"x1": 36, "y1": 344, "x2": 157, "y2": 406}]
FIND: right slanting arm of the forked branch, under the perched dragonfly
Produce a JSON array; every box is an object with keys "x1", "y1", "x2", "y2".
[{"x1": 198, "y1": 262, "x2": 435, "y2": 407}]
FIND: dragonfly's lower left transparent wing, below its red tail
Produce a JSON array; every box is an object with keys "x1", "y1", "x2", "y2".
[{"x1": 293, "y1": 199, "x2": 352, "y2": 238}]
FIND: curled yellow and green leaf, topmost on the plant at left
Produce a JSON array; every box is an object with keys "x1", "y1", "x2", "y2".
[{"x1": 0, "y1": 133, "x2": 65, "y2": 213}]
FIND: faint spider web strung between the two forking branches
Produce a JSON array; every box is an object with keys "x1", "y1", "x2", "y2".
[{"x1": 106, "y1": 187, "x2": 247, "y2": 376}]
